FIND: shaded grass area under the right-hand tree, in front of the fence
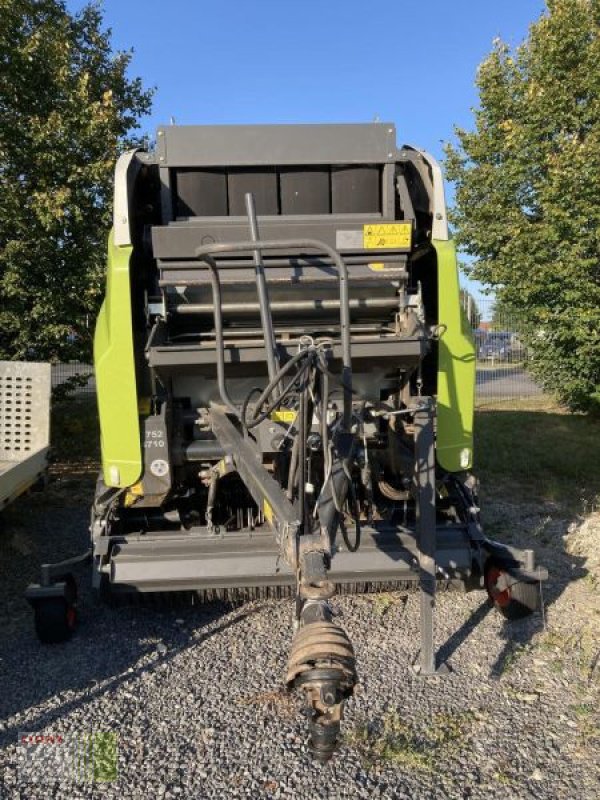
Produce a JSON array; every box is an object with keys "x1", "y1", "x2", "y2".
[{"x1": 475, "y1": 398, "x2": 600, "y2": 511}]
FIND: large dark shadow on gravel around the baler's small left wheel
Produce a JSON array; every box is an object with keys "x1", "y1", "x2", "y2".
[{"x1": 0, "y1": 484, "x2": 259, "y2": 748}]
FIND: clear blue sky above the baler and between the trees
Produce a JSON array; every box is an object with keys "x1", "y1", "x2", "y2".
[{"x1": 67, "y1": 0, "x2": 544, "y2": 310}]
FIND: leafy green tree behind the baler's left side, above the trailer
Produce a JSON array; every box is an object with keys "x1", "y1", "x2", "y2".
[{"x1": 0, "y1": 0, "x2": 151, "y2": 359}]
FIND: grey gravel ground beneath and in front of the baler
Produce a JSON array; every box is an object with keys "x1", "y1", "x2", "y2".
[{"x1": 0, "y1": 475, "x2": 600, "y2": 800}]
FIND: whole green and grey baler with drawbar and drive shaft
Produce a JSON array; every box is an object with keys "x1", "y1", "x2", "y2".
[{"x1": 29, "y1": 125, "x2": 546, "y2": 760}]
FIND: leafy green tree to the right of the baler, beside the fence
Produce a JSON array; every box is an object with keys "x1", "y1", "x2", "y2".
[{"x1": 446, "y1": 0, "x2": 600, "y2": 409}]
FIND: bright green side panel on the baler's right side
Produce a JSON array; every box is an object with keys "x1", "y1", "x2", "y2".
[{"x1": 433, "y1": 240, "x2": 475, "y2": 472}]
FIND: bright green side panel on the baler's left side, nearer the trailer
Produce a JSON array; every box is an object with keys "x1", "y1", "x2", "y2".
[{"x1": 94, "y1": 233, "x2": 142, "y2": 488}]
